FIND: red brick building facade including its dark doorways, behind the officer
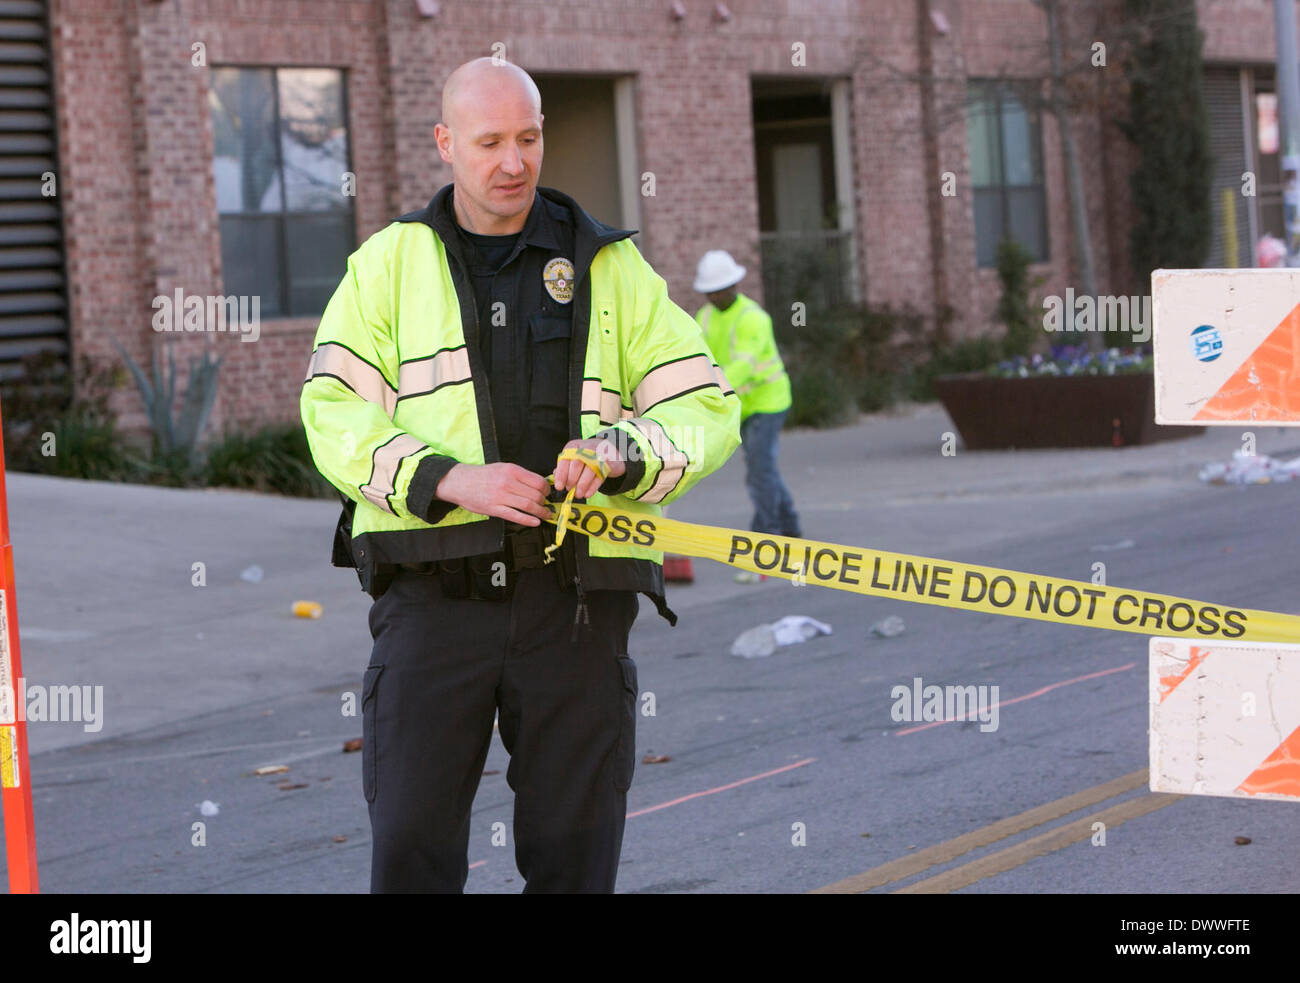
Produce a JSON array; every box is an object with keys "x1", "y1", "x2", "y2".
[{"x1": 25, "y1": 0, "x2": 1294, "y2": 430}]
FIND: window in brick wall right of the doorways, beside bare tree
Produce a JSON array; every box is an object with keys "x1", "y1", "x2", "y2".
[{"x1": 966, "y1": 82, "x2": 1048, "y2": 267}]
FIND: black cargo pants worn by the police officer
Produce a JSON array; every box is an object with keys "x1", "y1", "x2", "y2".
[{"x1": 361, "y1": 567, "x2": 637, "y2": 893}]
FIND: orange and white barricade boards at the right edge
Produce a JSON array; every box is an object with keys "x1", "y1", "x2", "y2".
[{"x1": 1149, "y1": 269, "x2": 1300, "y2": 801}]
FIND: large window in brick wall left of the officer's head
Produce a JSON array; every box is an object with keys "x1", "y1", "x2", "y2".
[{"x1": 208, "y1": 68, "x2": 356, "y2": 317}]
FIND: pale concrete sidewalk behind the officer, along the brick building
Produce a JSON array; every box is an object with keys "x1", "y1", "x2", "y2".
[{"x1": 8, "y1": 404, "x2": 1300, "y2": 753}]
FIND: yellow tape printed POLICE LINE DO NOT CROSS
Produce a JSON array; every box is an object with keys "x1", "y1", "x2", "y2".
[{"x1": 550, "y1": 502, "x2": 1300, "y2": 642}]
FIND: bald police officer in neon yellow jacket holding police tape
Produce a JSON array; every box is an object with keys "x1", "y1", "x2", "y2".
[{"x1": 302, "y1": 59, "x2": 740, "y2": 892}]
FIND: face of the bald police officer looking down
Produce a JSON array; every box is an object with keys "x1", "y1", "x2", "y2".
[{"x1": 434, "y1": 79, "x2": 543, "y2": 235}]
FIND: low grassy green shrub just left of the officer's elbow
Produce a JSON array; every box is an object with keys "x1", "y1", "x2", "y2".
[{"x1": 203, "y1": 424, "x2": 337, "y2": 498}]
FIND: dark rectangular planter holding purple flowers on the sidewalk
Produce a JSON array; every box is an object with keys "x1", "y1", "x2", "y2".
[{"x1": 935, "y1": 372, "x2": 1205, "y2": 450}]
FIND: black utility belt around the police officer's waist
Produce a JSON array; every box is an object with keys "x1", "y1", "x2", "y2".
[{"x1": 397, "y1": 523, "x2": 577, "y2": 602}]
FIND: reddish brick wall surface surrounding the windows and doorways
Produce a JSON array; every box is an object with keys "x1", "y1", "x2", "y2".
[{"x1": 51, "y1": 0, "x2": 1289, "y2": 429}]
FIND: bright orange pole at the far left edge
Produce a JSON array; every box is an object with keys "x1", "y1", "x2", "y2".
[{"x1": 0, "y1": 395, "x2": 40, "y2": 895}]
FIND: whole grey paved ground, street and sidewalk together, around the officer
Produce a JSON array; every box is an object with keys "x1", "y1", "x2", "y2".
[{"x1": 0, "y1": 406, "x2": 1300, "y2": 893}]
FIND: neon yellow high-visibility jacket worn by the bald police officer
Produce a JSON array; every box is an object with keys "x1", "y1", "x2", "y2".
[{"x1": 300, "y1": 185, "x2": 740, "y2": 599}]
